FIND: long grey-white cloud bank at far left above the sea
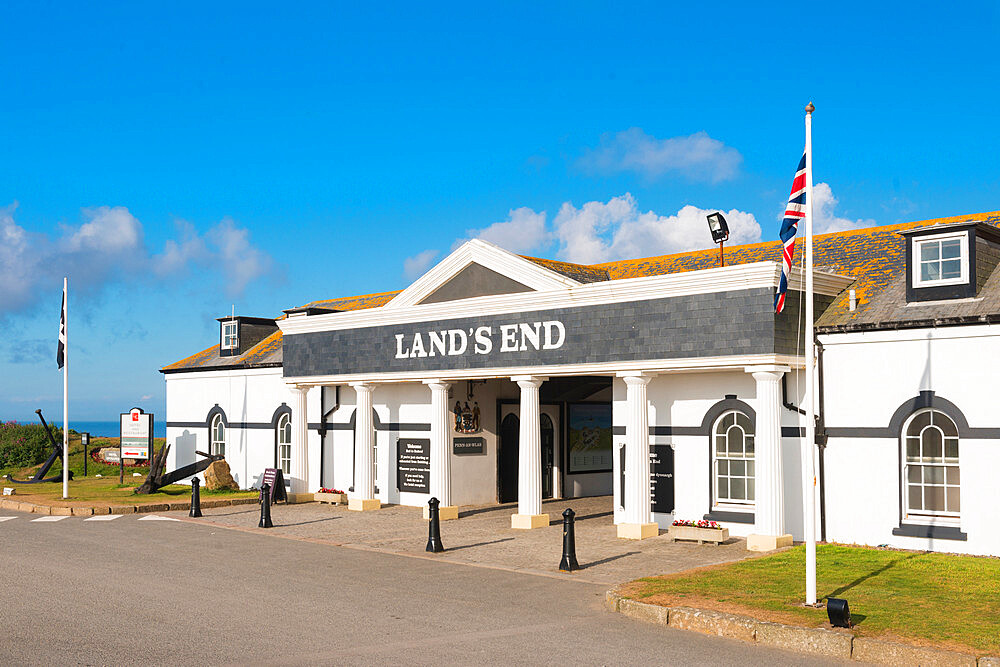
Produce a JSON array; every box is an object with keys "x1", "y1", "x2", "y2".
[{"x1": 0, "y1": 203, "x2": 274, "y2": 316}]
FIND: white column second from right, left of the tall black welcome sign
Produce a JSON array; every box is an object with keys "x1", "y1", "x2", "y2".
[{"x1": 618, "y1": 374, "x2": 659, "y2": 540}]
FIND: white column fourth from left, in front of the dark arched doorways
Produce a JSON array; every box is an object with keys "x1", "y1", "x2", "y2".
[{"x1": 510, "y1": 375, "x2": 549, "y2": 529}]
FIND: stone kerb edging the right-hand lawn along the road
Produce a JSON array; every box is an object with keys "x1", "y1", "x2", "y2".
[{"x1": 604, "y1": 589, "x2": 1000, "y2": 667}]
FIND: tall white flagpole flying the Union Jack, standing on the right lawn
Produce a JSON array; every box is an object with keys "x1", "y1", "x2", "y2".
[{"x1": 802, "y1": 102, "x2": 816, "y2": 604}]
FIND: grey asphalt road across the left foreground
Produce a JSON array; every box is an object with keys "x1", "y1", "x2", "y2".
[{"x1": 0, "y1": 512, "x2": 844, "y2": 665}]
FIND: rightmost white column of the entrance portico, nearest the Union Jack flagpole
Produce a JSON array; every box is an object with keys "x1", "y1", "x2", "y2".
[{"x1": 746, "y1": 366, "x2": 792, "y2": 551}]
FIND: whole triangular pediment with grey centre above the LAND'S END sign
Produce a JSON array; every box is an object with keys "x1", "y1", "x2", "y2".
[{"x1": 384, "y1": 239, "x2": 580, "y2": 308}]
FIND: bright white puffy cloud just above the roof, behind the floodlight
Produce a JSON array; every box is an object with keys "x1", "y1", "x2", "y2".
[{"x1": 553, "y1": 193, "x2": 761, "y2": 264}]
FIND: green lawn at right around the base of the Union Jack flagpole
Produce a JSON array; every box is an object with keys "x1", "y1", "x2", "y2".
[{"x1": 622, "y1": 545, "x2": 1000, "y2": 655}]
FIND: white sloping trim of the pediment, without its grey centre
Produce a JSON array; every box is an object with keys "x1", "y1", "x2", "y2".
[{"x1": 383, "y1": 239, "x2": 580, "y2": 309}]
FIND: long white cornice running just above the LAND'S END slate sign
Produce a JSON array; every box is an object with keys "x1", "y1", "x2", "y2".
[{"x1": 278, "y1": 262, "x2": 854, "y2": 334}]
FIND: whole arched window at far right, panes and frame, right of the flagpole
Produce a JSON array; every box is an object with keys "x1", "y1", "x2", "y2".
[{"x1": 903, "y1": 409, "x2": 961, "y2": 517}]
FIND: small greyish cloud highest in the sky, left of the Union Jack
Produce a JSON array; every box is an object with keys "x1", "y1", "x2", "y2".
[{"x1": 577, "y1": 127, "x2": 743, "y2": 182}]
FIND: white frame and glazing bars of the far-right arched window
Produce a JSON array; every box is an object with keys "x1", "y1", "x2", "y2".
[{"x1": 900, "y1": 408, "x2": 962, "y2": 526}]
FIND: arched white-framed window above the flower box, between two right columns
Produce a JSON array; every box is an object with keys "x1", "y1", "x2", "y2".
[{"x1": 712, "y1": 410, "x2": 756, "y2": 506}]
